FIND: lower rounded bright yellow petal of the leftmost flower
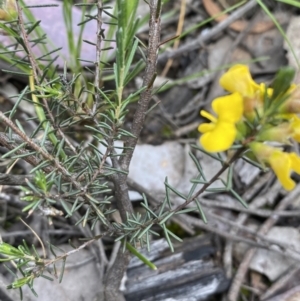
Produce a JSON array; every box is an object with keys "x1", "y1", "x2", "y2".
[{"x1": 199, "y1": 120, "x2": 237, "y2": 152}]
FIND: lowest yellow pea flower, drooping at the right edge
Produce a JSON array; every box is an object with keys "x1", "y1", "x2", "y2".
[{"x1": 249, "y1": 142, "x2": 300, "y2": 190}]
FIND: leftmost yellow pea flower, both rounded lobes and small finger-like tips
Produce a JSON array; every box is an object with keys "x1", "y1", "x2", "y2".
[{"x1": 198, "y1": 93, "x2": 243, "y2": 152}]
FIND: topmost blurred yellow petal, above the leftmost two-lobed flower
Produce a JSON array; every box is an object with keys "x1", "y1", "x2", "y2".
[{"x1": 220, "y1": 65, "x2": 260, "y2": 97}]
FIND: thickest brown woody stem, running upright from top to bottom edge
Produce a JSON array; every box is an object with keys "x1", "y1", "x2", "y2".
[{"x1": 104, "y1": 0, "x2": 161, "y2": 301}]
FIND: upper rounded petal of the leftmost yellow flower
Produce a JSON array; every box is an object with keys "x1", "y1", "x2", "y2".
[{"x1": 212, "y1": 93, "x2": 243, "y2": 123}]
